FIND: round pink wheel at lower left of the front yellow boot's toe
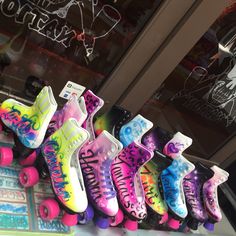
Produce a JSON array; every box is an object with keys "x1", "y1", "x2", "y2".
[{"x1": 39, "y1": 198, "x2": 60, "y2": 220}]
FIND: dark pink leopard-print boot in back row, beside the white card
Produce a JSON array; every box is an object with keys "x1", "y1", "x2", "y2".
[{"x1": 82, "y1": 90, "x2": 104, "y2": 141}]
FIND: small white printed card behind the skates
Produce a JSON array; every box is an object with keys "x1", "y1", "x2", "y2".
[{"x1": 59, "y1": 81, "x2": 85, "y2": 100}]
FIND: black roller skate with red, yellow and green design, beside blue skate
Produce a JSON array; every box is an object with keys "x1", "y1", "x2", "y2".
[{"x1": 140, "y1": 150, "x2": 172, "y2": 228}]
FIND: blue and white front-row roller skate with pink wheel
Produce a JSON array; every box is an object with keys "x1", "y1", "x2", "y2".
[{"x1": 160, "y1": 155, "x2": 195, "y2": 229}]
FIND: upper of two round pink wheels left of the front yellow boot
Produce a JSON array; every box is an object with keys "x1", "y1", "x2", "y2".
[{"x1": 19, "y1": 166, "x2": 39, "y2": 187}]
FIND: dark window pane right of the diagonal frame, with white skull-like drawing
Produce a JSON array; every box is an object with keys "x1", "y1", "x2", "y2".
[{"x1": 140, "y1": 1, "x2": 236, "y2": 159}]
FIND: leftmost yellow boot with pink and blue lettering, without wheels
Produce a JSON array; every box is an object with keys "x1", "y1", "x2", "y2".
[{"x1": 0, "y1": 87, "x2": 57, "y2": 148}]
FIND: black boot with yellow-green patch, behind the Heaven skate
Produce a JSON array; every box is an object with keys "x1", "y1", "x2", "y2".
[{"x1": 94, "y1": 106, "x2": 131, "y2": 139}]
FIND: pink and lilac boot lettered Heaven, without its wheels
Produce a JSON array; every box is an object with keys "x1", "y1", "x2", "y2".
[{"x1": 79, "y1": 131, "x2": 123, "y2": 216}]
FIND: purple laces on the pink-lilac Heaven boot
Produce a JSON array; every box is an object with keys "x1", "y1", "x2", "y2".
[{"x1": 100, "y1": 159, "x2": 116, "y2": 200}]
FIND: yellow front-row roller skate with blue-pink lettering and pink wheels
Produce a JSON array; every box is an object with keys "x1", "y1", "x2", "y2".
[{"x1": 19, "y1": 118, "x2": 89, "y2": 226}]
